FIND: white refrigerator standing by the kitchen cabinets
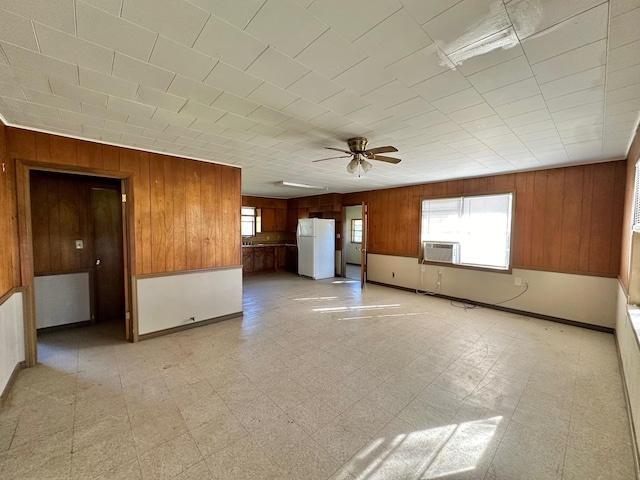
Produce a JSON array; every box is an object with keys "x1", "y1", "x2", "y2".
[{"x1": 296, "y1": 218, "x2": 336, "y2": 280}]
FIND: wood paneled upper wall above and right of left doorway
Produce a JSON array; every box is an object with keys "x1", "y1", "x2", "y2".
[{"x1": 3, "y1": 127, "x2": 241, "y2": 275}]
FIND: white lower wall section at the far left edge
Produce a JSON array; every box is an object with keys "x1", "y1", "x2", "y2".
[{"x1": 0, "y1": 292, "x2": 25, "y2": 394}]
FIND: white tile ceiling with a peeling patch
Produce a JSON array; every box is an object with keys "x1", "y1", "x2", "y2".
[{"x1": 0, "y1": 0, "x2": 640, "y2": 197}]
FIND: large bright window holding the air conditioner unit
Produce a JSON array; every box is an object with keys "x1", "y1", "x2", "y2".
[{"x1": 420, "y1": 193, "x2": 513, "y2": 270}]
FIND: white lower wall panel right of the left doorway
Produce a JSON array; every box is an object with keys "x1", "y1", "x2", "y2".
[{"x1": 134, "y1": 267, "x2": 242, "y2": 335}]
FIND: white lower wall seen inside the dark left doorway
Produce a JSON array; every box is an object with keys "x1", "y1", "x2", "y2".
[{"x1": 33, "y1": 272, "x2": 91, "y2": 328}]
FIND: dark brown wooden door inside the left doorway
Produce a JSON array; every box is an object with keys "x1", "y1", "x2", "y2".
[{"x1": 91, "y1": 188, "x2": 125, "y2": 321}]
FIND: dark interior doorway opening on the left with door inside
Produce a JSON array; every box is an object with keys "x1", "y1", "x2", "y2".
[{"x1": 26, "y1": 169, "x2": 131, "y2": 364}]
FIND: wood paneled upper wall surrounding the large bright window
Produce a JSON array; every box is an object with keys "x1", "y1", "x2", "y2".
[{"x1": 336, "y1": 161, "x2": 627, "y2": 276}]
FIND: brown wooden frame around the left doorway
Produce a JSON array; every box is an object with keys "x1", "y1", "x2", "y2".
[{"x1": 15, "y1": 158, "x2": 138, "y2": 367}]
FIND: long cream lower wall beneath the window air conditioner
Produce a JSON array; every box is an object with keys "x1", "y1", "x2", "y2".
[{"x1": 367, "y1": 254, "x2": 618, "y2": 328}]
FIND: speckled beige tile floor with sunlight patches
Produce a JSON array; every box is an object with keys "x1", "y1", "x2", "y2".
[{"x1": 0, "y1": 273, "x2": 634, "y2": 480}]
